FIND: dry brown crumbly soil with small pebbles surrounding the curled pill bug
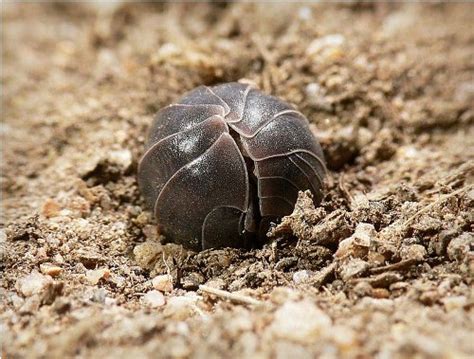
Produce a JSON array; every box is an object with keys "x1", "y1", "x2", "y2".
[{"x1": 0, "y1": 3, "x2": 474, "y2": 358}]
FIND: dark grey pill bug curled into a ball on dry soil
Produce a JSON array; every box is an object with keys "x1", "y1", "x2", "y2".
[{"x1": 138, "y1": 83, "x2": 325, "y2": 250}]
